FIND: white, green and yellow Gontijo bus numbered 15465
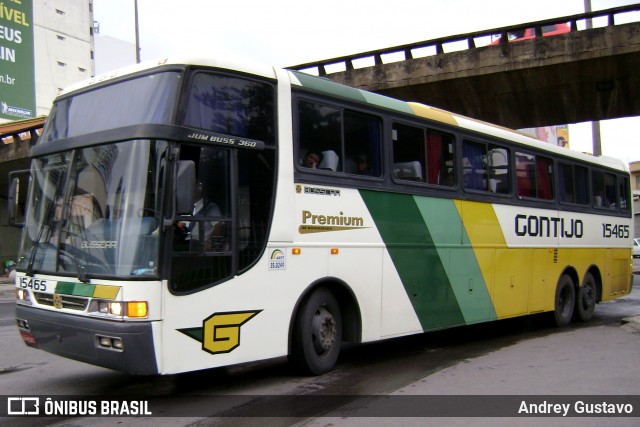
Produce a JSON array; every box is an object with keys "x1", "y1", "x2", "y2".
[{"x1": 10, "y1": 59, "x2": 633, "y2": 374}]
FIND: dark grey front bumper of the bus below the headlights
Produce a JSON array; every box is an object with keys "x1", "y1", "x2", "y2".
[{"x1": 16, "y1": 304, "x2": 158, "y2": 375}]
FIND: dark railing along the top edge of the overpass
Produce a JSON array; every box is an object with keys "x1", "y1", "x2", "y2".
[{"x1": 287, "y1": 4, "x2": 640, "y2": 77}]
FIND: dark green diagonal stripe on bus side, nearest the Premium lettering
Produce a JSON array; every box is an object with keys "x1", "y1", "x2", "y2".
[{"x1": 360, "y1": 190, "x2": 465, "y2": 330}]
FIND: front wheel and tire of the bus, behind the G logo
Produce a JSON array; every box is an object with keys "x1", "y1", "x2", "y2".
[{"x1": 292, "y1": 288, "x2": 342, "y2": 375}]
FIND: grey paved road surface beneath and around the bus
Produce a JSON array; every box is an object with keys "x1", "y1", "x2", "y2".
[{"x1": 0, "y1": 277, "x2": 640, "y2": 427}]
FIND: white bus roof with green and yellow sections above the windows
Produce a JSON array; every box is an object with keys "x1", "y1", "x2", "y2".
[{"x1": 60, "y1": 56, "x2": 629, "y2": 171}]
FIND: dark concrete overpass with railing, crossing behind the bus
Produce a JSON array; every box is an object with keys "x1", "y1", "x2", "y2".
[{"x1": 289, "y1": 4, "x2": 640, "y2": 129}]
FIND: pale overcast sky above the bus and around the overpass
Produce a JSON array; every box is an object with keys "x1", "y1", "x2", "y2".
[{"x1": 94, "y1": 0, "x2": 640, "y2": 162}]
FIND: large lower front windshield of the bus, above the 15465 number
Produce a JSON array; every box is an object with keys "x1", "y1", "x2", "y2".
[{"x1": 18, "y1": 140, "x2": 168, "y2": 281}]
